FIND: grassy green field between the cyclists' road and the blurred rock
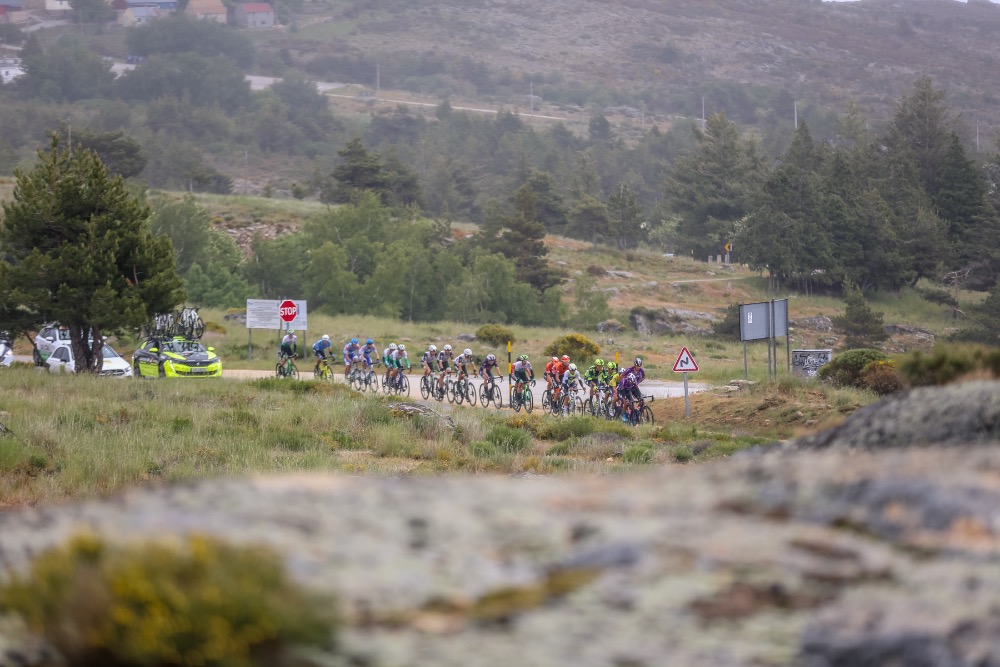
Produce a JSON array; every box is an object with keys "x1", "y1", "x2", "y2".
[{"x1": 0, "y1": 367, "x2": 873, "y2": 508}]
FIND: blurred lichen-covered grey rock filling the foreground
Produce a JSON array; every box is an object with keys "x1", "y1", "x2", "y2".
[{"x1": 0, "y1": 383, "x2": 1000, "y2": 667}]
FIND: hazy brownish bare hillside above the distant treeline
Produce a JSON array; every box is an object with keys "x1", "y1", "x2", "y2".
[{"x1": 265, "y1": 0, "x2": 1000, "y2": 136}]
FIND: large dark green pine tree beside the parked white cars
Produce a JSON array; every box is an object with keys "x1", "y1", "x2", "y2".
[{"x1": 0, "y1": 136, "x2": 183, "y2": 371}]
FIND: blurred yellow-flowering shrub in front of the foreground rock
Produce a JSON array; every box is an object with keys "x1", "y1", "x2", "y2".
[{"x1": 0, "y1": 536, "x2": 336, "y2": 667}]
